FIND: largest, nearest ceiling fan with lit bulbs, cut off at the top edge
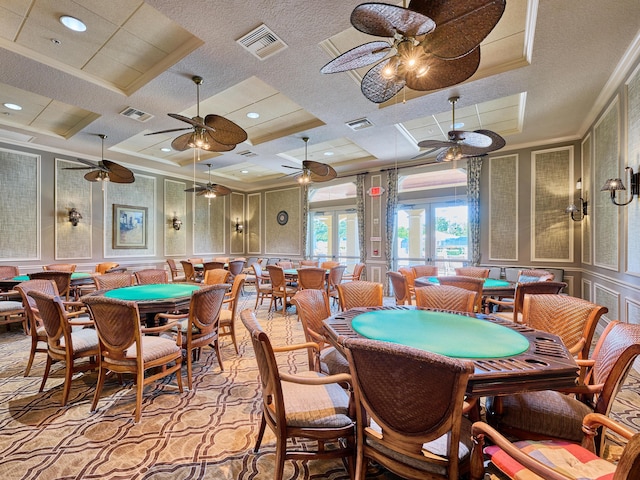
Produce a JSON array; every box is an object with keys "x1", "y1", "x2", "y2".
[{"x1": 320, "y1": 0, "x2": 506, "y2": 103}]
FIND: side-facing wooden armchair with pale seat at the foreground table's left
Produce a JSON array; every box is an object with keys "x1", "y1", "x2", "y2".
[{"x1": 240, "y1": 310, "x2": 355, "y2": 480}]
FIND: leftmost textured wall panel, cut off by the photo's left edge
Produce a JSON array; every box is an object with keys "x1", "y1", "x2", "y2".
[{"x1": 0, "y1": 149, "x2": 40, "y2": 260}]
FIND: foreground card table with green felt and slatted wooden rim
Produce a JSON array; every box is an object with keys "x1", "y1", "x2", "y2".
[{"x1": 324, "y1": 306, "x2": 578, "y2": 396}]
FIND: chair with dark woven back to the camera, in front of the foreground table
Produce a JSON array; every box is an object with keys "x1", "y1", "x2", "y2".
[{"x1": 344, "y1": 338, "x2": 474, "y2": 480}]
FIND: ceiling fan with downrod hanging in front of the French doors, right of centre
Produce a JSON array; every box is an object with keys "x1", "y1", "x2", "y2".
[{"x1": 414, "y1": 96, "x2": 506, "y2": 162}]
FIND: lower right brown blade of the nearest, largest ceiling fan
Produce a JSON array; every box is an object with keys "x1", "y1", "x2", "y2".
[{"x1": 406, "y1": 46, "x2": 480, "y2": 91}]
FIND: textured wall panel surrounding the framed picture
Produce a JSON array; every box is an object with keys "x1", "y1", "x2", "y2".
[{"x1": 104, "y1": 173, "x2": 156, "y2": 258}]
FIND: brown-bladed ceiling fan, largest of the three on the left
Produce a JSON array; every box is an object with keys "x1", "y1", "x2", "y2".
[{"x1": 145, "y1": 75, "x2": 247, "y2": 152}]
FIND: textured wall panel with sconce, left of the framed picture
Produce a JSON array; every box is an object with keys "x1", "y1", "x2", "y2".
[{"x1": 55, "y1": 158, "x2": 93, "y2": 260}]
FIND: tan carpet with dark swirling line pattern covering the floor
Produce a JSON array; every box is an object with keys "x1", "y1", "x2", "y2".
[{"x1": 0, "y1": 289, "x2": 640, "y2": 480}]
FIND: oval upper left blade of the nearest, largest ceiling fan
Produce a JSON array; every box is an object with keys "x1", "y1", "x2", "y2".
[{"x1": 351, "y1": 3, "x2": 436, "y2": 37}]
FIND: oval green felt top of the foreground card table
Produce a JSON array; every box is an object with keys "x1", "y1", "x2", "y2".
[{"x1": 351, "y1": 310, "x2": 529, "y2": 358}]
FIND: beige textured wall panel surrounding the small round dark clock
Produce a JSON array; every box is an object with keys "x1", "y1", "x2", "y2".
[{"x1": 264, "y1": 187, "x2": 302, "y2": 255}]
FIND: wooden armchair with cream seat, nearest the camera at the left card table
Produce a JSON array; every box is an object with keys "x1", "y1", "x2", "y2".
[{"x1": 84, "y1": 295, "x2": 183, "y2": 423}]
